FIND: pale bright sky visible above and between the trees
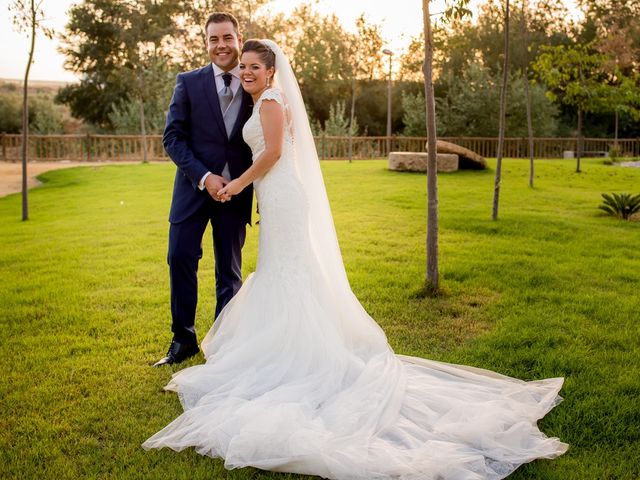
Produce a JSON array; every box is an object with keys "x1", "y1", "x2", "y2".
[{"x1": 0, "y1": 0, "x2": 573, "y2": 81}]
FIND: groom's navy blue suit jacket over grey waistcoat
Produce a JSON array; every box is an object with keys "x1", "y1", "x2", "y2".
[{"x1": 162, "y1": 65, "x2": 253, "y2": 223}]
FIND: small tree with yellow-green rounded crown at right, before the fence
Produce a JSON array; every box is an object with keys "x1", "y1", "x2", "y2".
[{"x1": 534, "y1": 45, "x2": 606, "y2": 172}]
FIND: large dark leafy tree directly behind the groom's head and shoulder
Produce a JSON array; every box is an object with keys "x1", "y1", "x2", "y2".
[{"x1": 57, "y1": 0, "x2": 284, "y2": 133}]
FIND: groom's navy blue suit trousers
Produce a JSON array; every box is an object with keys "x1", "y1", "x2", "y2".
[{"x1": 167, "y1": 196, "x2": 246, "y2": 343}]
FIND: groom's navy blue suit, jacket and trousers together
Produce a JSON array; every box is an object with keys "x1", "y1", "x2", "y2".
[{"x1": 162, "y1": 65, "x2": 253, "y2": 343}]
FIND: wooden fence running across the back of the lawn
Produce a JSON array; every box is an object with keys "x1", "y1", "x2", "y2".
[{"x1": 0, "y1": 134, "x2": 640, "y2": 162}]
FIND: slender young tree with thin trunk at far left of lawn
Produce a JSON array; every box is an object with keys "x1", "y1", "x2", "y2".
[{"x1": 9, "y1": 0, "x2": 53, "y2": 221}]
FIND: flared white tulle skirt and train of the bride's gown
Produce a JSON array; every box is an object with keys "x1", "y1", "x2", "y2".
[{"x1": 143, "y1": 268, "x2": 567, "y2": 480}]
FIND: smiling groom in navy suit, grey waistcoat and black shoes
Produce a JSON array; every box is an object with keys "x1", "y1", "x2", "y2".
[{"x1": 154, "y1": 12, "x2": 253, "y2": 366}]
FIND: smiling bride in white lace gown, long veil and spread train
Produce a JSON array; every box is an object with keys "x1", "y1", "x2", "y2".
[{"x1": 143, "y1": 40, "x2": 567, "y2": 480}]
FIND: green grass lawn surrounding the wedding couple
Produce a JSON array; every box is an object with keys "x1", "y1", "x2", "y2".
[{"x1": 0, "y1": 160, "x2": 640, "y2": 480}]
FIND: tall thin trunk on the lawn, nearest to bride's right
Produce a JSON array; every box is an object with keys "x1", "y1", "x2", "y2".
[{"x1": 422, "y1": 0, "x2": 440, "y2": 295}]
